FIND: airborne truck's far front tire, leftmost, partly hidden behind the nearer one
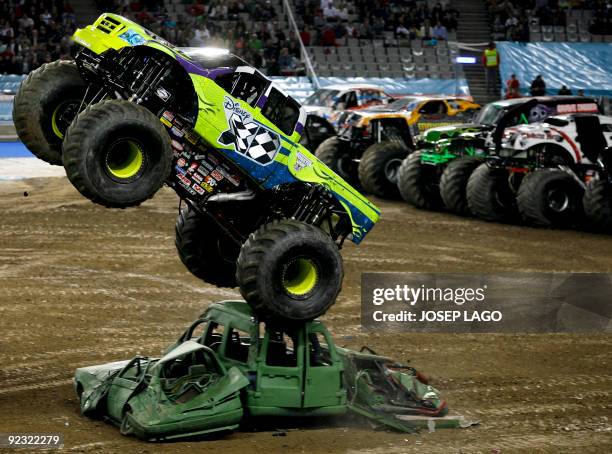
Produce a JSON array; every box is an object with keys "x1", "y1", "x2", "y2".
[{"x1": 13, "y1": 60, "x2": 86, "y2": 165}]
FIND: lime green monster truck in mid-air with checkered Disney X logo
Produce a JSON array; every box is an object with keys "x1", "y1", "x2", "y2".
[{"x1": 13, "y1": 14, "x2": 380, "y2": 321}]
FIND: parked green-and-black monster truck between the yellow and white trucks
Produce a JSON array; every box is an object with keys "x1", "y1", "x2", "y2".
[{"x1": 397, "y1": 96, "x2": 599, "y2": 214}]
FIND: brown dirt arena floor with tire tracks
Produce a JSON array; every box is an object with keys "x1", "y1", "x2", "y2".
[{"x1": 0, "y1": 178, "x2": 612, "y2": 453}]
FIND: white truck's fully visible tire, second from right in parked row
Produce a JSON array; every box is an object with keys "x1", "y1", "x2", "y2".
[{"x1": 516, "y1": 169, "x2": 584, "y2": 227}]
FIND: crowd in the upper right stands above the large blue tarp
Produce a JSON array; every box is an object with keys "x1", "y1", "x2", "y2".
[{"x1": 486, "y1": 0, "x2": 612, "y2": 41}]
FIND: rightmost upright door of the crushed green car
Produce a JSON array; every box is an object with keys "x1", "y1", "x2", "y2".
[{"x1": 304, "y1": 323, "x2": 346, "y2": 408}]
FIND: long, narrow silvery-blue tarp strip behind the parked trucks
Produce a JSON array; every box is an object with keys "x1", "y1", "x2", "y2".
[{"x1": 271, "y1": 77, "x2": 470, "y2": 101}]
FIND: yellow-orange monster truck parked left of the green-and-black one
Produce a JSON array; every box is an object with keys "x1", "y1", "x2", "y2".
[{"x1": 315, "y1": 96, "x2": 480, "y2": 198}]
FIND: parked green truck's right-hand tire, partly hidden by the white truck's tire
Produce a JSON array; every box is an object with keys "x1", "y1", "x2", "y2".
[{"x1": 440, "y1": 156, "x2": 482, "y2": 215}]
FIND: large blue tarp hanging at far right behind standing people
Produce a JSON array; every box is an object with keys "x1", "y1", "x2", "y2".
[{"x1": 497, "y1": 42, "x2": 612, "y2": 96}]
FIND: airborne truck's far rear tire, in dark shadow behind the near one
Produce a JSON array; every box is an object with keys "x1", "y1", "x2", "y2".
[{"x1": 174, "y1": 208, "x2": 240, "y2": 287}]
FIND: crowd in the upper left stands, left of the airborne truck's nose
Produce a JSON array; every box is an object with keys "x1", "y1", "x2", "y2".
[{"x1": 0, "y1": 0, "x2": 75, "y2": 74}]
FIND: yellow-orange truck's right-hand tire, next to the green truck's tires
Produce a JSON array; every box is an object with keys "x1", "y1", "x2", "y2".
[{"x1": 358, "y1": 142, "x2": 410, "y2": 199}]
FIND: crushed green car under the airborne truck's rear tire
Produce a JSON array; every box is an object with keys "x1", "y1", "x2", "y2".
[{"x1": 74, "y1": 301, "x2": 466, "y2": 440}]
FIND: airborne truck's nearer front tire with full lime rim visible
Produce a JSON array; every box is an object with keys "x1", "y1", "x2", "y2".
[{"x1": 63, "y1": 100, "x2": 173, "y2": 208}]
